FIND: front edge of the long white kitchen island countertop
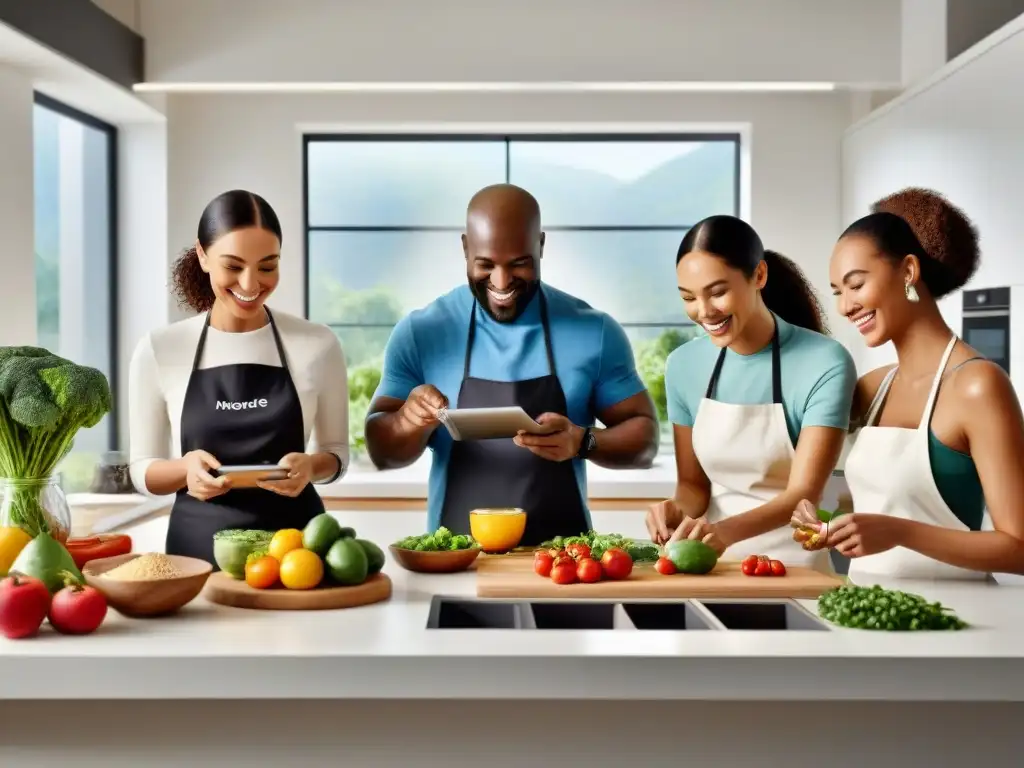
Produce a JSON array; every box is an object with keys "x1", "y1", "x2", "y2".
[{"x1": 0, "y1": 655, "x2": 1024, "y2": 701}]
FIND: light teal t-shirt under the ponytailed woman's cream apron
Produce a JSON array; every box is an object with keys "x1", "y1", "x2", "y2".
[{"x1": 665, "y1": 315, "x2": 857, "y2": 445}]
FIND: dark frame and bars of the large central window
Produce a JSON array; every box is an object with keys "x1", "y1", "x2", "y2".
[{"x1": 302, "y1": 131, "x2": 742, "y2": 331}]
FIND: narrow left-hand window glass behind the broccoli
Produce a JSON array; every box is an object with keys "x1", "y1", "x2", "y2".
[{"x1": 34, "y1": 94, "x2": 117, "y2": 490}]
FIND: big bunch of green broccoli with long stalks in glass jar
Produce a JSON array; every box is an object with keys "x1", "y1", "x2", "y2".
[{"x1": 0, "y1": 347, "x2": 113, "y2": 537}]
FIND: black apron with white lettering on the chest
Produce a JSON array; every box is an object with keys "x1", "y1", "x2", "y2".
[{"x1": 166, "y1": 309, "x2": 325, "y2": 568}]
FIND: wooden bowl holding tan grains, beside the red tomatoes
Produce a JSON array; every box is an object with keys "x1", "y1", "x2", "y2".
[{"x1": 82, "y1": 552, "x2": 213, "y2": 617}]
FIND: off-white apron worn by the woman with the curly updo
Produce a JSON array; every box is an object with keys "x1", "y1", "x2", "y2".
[{"x1": 845, "y1": 336, "x2": 989, "y2": 583}]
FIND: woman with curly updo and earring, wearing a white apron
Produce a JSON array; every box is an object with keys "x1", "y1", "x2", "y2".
[{"x1": 793, "y1": 188, "x2": 1024, "y2": 582}]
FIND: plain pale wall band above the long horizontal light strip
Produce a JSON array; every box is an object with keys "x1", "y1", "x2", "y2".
[{"x1": 139, "y1": 0, "x2": 900, "y2": 84}]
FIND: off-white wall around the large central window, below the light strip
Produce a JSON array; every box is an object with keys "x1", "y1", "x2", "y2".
[{"x1": 164, "y1": 94, "x2": 849, "y2": 329}]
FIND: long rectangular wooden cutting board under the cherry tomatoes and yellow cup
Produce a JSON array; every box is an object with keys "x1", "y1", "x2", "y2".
[{"x1": 476, "y1": 555, "x2": 843, "y2": 600}]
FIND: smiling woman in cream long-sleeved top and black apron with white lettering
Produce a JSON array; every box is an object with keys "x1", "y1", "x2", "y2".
[{"x1": 128, "y1": 189, "x2": 348, "y2": 565}]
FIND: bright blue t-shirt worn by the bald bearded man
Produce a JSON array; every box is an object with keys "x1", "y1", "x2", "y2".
[{"x1": 375, "y1": 285, "x2": 644, "y2": 531}]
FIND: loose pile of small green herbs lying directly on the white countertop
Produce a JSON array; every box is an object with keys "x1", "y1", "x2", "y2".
[{"x1": 818, "y1": 585, "x2": 968, "y2": 632}]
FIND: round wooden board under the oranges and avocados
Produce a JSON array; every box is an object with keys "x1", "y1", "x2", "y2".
[{"x1": 203, "y1": 570, "x2": 391, "y2": 610}]
